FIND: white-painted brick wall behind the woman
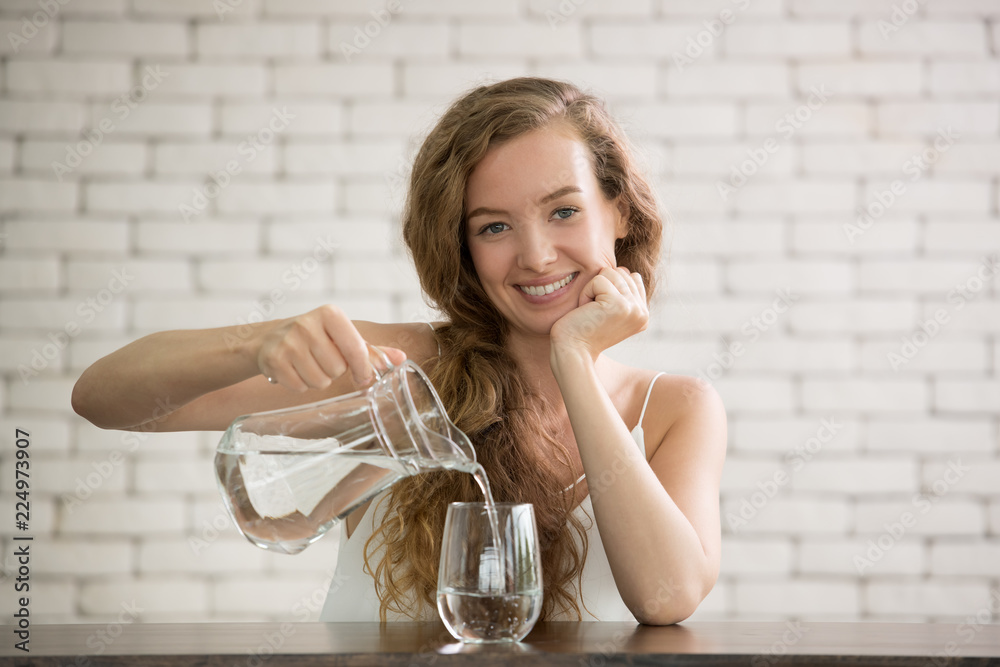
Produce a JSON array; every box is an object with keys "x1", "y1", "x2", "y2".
[{"x1": 0, "y1": 0, "x2": 1000, "y2": 622}]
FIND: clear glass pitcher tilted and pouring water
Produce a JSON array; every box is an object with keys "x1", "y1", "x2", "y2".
[{"x1": 215, "y1": 345, "x2": 476, "y2": 554}]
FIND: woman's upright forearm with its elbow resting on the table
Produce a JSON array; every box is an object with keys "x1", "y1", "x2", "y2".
[{"x1": 552, "y1": 347, "x2": 713, "y2": 624}]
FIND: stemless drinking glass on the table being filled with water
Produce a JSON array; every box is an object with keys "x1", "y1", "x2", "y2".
[{"x1": 438, "y1": 503, "x2": 542, "y2": 644}]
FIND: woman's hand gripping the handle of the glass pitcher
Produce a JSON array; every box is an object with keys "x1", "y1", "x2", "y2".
[{"x1": 254, "y1": 304, "x2": 406, "y2": 392}]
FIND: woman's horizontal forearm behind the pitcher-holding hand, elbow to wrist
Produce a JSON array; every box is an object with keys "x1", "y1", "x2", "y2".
[{"x1": 72, "y1": 322, "x2": 273, "y2": 428}]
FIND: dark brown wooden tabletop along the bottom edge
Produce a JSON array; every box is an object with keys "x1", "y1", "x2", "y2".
[{"x1": 0, "y1": 622, "x2": 1000, "y2": 667}]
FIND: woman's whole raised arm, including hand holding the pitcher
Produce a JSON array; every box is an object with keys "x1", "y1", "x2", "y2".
[{"x1": 72, "y1": 305, "x2": 436, "y2": 431}]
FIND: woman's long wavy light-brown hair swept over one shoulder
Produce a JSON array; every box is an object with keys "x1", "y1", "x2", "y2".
[{"x1": 364, "y1": 77, "x2": 663, "y2": 622}]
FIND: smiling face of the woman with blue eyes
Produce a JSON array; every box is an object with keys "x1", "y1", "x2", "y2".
[{"x1": 465, "y1": 126, "x2": 627, "y2": 335}]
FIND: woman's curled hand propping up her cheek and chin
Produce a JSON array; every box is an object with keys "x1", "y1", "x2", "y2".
[{"x1": 551, "y1": 266, "x2": 649, "y2": 359}]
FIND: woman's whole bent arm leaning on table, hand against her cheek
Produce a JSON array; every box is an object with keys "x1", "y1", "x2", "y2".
[{"x1": 550, "y1": 272, "x2": 727, "y2": 625}]
